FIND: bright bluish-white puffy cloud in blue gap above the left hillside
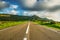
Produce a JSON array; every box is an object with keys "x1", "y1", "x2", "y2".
[{"x1": 1, "y1": 4, "x2": 19, "y2": 15}]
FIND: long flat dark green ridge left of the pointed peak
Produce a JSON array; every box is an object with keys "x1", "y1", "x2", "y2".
[{"x1": 0, "y1": 14, "x2": 30, "y2": 21}]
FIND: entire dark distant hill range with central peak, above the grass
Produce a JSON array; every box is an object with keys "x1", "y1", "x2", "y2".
[{"x1": 0, "y1": 14, "x2": 54, "y2": 21}]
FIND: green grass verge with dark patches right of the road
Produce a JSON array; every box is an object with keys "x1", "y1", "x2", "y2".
[{"x1": 34, "y1": 21, "x2": 60, "y2": 30}]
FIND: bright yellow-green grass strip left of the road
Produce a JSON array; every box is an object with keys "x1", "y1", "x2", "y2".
[{"x1": 0, "y1": 21, "x2": 25, "y2": 30}]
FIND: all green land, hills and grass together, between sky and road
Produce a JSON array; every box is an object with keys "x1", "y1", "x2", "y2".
[{"x1": 0, "y1": 14, "x2": 60, "y2": 29}]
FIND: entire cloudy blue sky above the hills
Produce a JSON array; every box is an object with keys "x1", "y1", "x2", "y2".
[{"x1": 0, "y1": 0, "x2": 60, "y2": 22}]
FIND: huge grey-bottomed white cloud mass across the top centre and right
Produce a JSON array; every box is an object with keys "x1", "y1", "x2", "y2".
[{"x1": 19, "y1": 0, "x2": 60, "y2": 12}]
